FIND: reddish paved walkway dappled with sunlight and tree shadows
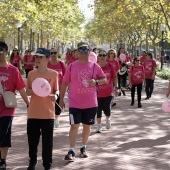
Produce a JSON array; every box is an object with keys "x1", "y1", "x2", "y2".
[{"x1": 7, "y1": 78, "x2": 170, "y2": 170}]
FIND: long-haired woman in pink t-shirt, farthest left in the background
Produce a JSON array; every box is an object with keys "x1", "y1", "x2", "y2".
[{"x1": 10, "y1": 48, "x2": 21, "y2": 71}]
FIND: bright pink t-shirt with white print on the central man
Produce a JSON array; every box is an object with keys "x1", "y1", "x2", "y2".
[{"x1": 63, "y1": 61, "x2": 106, "y2": 109}]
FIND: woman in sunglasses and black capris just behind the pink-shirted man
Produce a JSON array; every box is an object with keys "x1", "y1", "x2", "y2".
[{"x1": 96, "y1": 50, "x2": 117, "y2": 133}]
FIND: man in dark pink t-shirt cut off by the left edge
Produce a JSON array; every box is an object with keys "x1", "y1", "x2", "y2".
[{"x1": 0, "y1": 41, "x2": 29, "y2": 169}]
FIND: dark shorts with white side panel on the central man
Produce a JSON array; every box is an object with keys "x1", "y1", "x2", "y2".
[{"x1": 69, "y1": 107, "x2": 97, "y2": 125}]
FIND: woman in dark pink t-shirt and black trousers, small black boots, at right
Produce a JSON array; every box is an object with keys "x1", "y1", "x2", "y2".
[{"x1": 129, "y1": 57, "x2": 145, "y2": 108}]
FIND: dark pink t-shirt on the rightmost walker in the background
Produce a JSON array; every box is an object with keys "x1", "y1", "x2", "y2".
[{"x1": 144, "y1": 59, "x2": 156, "y2": 79}]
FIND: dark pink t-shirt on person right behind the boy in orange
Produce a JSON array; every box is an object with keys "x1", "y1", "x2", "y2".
[{"x1": 47, "y1": 61, "x2": 66, "y2": 88}]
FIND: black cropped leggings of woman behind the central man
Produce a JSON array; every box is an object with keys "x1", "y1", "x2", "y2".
[{"x1": 97, "y1": 96, "x2": 113, "y2": 118}]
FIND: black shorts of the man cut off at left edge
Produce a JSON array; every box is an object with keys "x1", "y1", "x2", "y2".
[{"x1": 0, "y1": 116, "x2": 13, "y2": 147}]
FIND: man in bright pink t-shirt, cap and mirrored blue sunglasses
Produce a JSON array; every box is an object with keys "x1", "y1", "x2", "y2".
[{"x1": 59, "y1": 42, "x2": 106, "y2": 161}]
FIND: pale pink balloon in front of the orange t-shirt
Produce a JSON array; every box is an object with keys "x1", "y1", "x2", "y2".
[{"x1": 32, "y1": 78, "x2": 51, "y2": 97}]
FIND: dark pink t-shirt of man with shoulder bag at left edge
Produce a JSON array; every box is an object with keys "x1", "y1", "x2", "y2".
[{"x1": 0, "y1": 64, "x2": 25, "y2": 117}]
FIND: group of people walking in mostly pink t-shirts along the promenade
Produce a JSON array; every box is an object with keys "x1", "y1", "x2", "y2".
[{"x1": 0, "y1": 42, "x2": 156, "y2": 170}]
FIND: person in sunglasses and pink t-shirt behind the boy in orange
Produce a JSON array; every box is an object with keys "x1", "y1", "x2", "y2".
[{"x1": 47, "y1": 48, "x2": 66, "y2": 128}]
